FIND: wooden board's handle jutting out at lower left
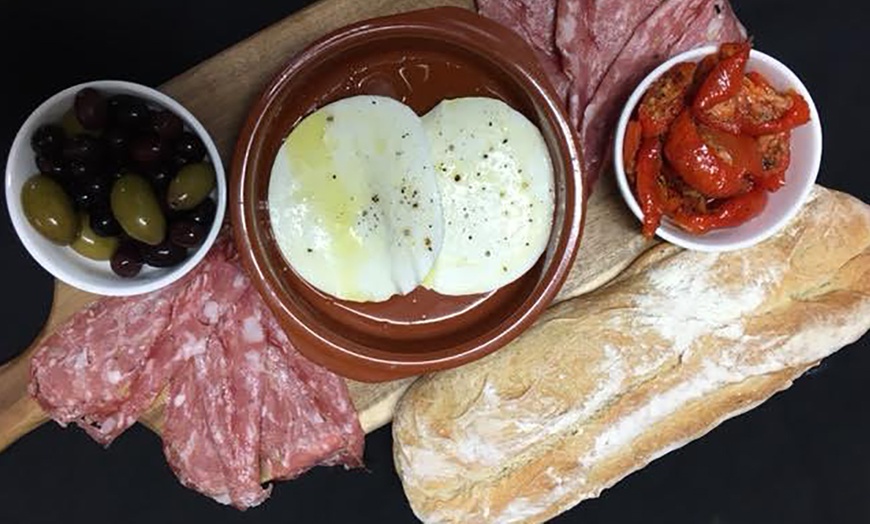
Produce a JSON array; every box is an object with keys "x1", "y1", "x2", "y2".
[{"x1": 0, "y1": 350, "x2": 48, "y2": 451}]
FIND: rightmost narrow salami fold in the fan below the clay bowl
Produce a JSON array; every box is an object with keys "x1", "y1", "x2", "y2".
[{"x1": 263, "y1": 304, "x2": 365, "y2": 467}]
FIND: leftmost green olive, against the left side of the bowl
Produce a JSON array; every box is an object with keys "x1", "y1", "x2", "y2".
[{"x1": 21, "y1": 175, "x2": 79, "y2": 246}]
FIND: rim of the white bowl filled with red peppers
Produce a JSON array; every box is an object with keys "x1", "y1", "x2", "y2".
[{"x1": 613, "y1": 45, "x2": 824, "y2": 252}]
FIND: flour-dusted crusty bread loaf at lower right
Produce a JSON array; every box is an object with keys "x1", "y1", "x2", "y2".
[{"x1": 393, "y1": 188, "x2": 870, "y2": 523}]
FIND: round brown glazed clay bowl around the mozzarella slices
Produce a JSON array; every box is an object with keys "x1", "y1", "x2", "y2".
[{"x1": 229, "y1": 8, "x2": 585, "y2": 382}]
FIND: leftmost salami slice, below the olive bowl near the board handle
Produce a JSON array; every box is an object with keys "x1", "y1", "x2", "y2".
[{"x1": 30, "y1": 291, "x2": 171, "y2": 434}]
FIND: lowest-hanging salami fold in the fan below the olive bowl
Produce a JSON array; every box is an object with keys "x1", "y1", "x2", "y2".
[{"x1": 163, "y1": 361, "x2": 232, "y2": 504}]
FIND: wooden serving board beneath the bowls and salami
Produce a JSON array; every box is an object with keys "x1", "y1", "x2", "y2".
[{"x1": 0, "y1": 0, "x2": 653, "y2": 451}]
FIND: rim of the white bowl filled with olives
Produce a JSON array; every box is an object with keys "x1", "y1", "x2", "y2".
[{"x1": 5, "y1": 80, "x2": 227, "y2": 296}]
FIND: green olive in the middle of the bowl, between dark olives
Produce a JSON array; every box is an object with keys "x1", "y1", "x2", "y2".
[{"x1": 111, "y1": 173, "x2": 166, "y2": 246}]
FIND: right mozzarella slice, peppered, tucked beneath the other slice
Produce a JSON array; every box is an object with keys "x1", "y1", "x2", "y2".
[{"x1": 423, "y1": 98, "x2": 554, "y2": 295}]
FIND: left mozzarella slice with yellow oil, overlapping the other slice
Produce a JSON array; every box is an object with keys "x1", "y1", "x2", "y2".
[{"x1": 269, "y1": 96, "x2": 443, "y2": 302}]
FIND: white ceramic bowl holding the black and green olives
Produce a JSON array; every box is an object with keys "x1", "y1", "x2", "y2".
[{"x1": 6, "y1": 80, "x2": 227, "y2": 296}]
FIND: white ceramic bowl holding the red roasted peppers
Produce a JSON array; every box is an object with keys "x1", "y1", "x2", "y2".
[{"x1": 613, "y1": 46, "x2": 822, "y2": 251}]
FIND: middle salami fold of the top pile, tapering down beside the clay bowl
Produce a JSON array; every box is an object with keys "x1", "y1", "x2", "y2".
[{"x1": 555, "y1": 0, "x2": 663, "y2": 128}]
